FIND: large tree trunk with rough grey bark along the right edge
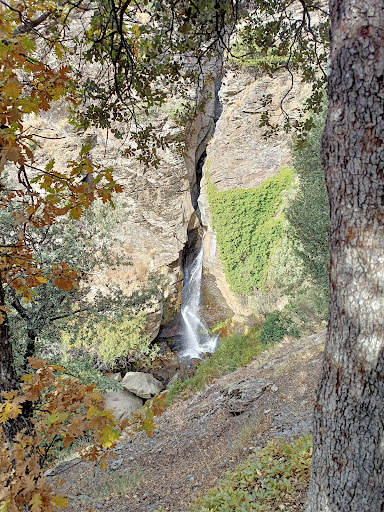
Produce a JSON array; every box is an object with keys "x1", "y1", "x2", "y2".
[{"x1": 307, "y1": 0, "x2": 384, "y2": 512}]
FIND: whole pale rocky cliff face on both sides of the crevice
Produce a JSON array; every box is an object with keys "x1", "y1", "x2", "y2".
[{"x1": 29, "y1": 62, "x2": 306, "y2": 339}]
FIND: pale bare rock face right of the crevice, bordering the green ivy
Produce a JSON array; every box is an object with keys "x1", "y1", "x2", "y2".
[{"x1": 199, "y1": 71, "x2": 309, "y2": 315}]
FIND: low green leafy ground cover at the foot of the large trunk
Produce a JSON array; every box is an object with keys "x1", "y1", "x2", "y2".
[{"x1": 191, "y1": 435, "x2": 312, "y2": 512}]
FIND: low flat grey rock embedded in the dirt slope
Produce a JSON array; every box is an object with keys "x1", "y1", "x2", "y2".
[{"x1": 223, "y1": 379, "x2": 273, "y2": 414}]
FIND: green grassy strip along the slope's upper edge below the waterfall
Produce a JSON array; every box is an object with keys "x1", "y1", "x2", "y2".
[{"x1": 167, "y1": 331, "x2": 265, "y2": 405}]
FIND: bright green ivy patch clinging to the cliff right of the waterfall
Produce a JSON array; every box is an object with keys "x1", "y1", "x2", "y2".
[{"x1": 207, "y1": 168, "x2": 293, "y2": 295}]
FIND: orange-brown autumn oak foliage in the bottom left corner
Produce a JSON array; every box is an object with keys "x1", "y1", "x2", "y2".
[{"x1": 0, "y1": 358, "x2": 165, "y2": 512}]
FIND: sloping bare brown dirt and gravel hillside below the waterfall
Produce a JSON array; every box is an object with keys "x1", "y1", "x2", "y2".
[{"x1": 53, "y1": 332, "x2": 324, "y2": 512}]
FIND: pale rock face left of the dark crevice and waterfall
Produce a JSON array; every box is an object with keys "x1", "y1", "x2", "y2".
[{"x1": 27, "y1": 65, "x2": 220, "y2": 339}]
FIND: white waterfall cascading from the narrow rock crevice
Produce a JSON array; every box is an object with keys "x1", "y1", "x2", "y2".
[{"x1": 179, "y1": 237, "x2": 218, "y2": 359}]
